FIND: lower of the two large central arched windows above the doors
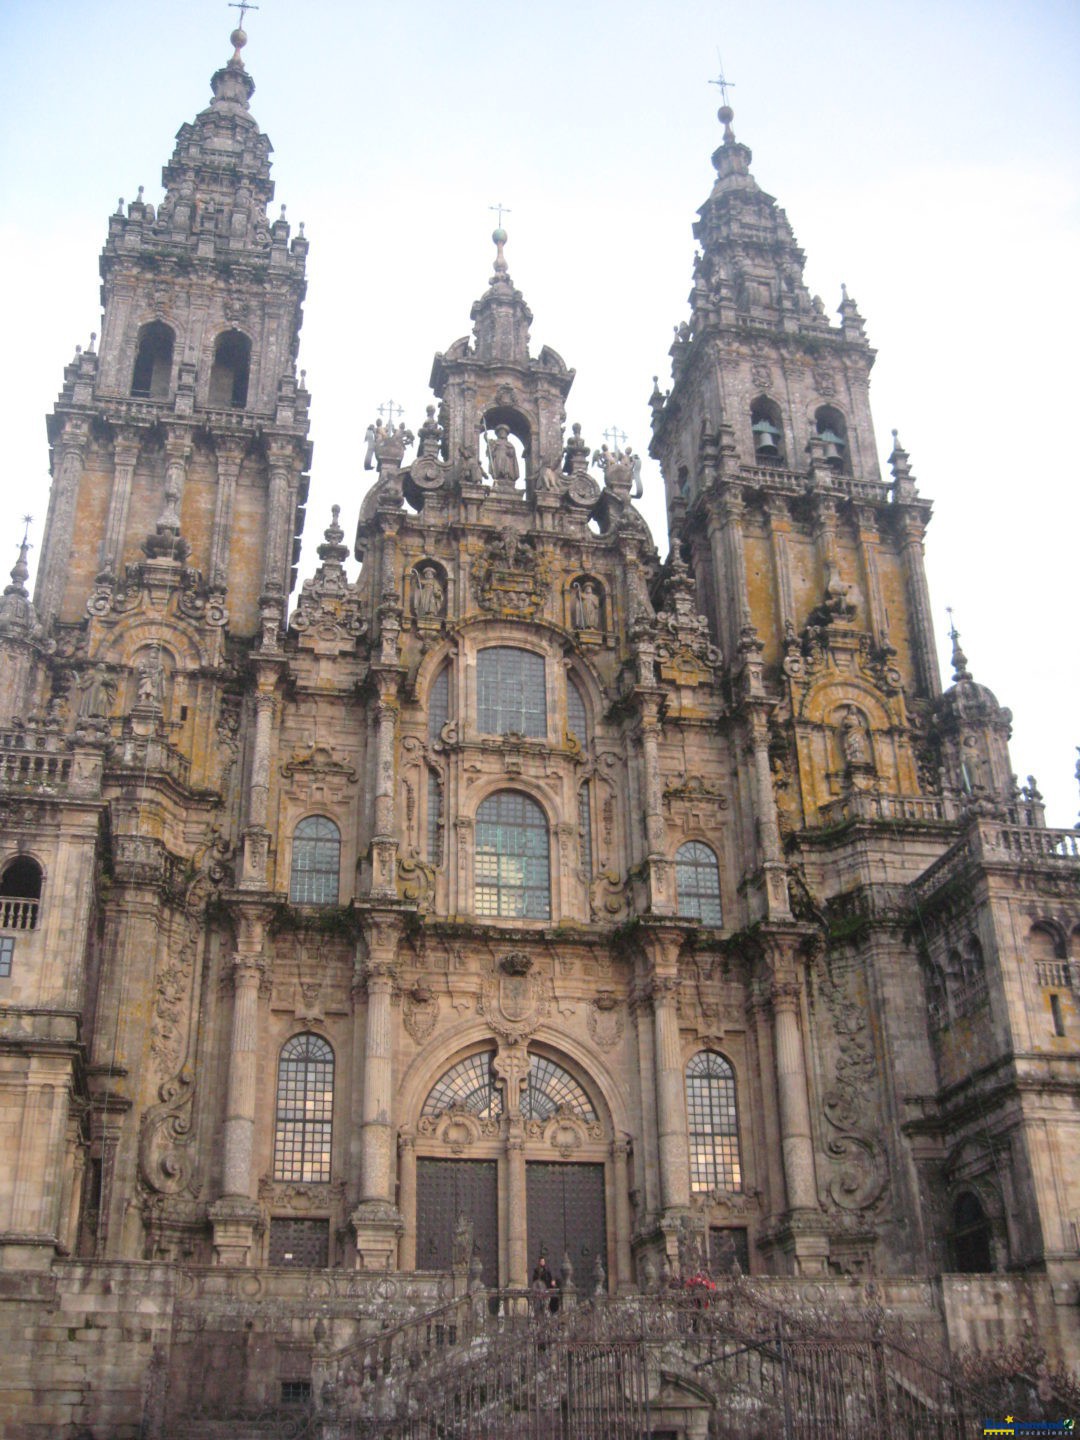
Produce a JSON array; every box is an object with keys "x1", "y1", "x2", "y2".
[{"x1": 475, "y1": 791, "x2": 552, "y2": 920}]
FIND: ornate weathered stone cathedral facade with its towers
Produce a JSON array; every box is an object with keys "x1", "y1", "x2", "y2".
[{"x1": 0, "y1": 32, "x2": 1080, "y2": 1436}]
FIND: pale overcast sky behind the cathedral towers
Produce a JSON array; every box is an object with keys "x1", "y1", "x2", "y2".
[{"x1": 0, "y1": 0, "x2": 1080, "y2": 825}]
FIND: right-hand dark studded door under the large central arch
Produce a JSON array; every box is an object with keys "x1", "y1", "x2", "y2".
[{"x1": 526, "y1": 1161, "x2": 608, "y2": 1290}]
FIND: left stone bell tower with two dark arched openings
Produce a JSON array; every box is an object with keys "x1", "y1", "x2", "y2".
[{"x1": 35, "y1": 30, "x2": 310, "y2": 653}]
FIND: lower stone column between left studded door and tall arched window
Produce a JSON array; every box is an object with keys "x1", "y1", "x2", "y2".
[{"x1": 350, "y1": 916, "x2": 402, "y2": 1270}]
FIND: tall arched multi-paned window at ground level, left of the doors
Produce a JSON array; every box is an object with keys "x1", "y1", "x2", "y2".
[{"x1": 274, "y1": 1034, "x2": 334, "y2": 1182}]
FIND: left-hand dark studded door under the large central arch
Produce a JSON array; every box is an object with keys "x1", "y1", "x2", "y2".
[{"x1": 416, "y1": 1159, "x2": 498, "y2": 1287}]
